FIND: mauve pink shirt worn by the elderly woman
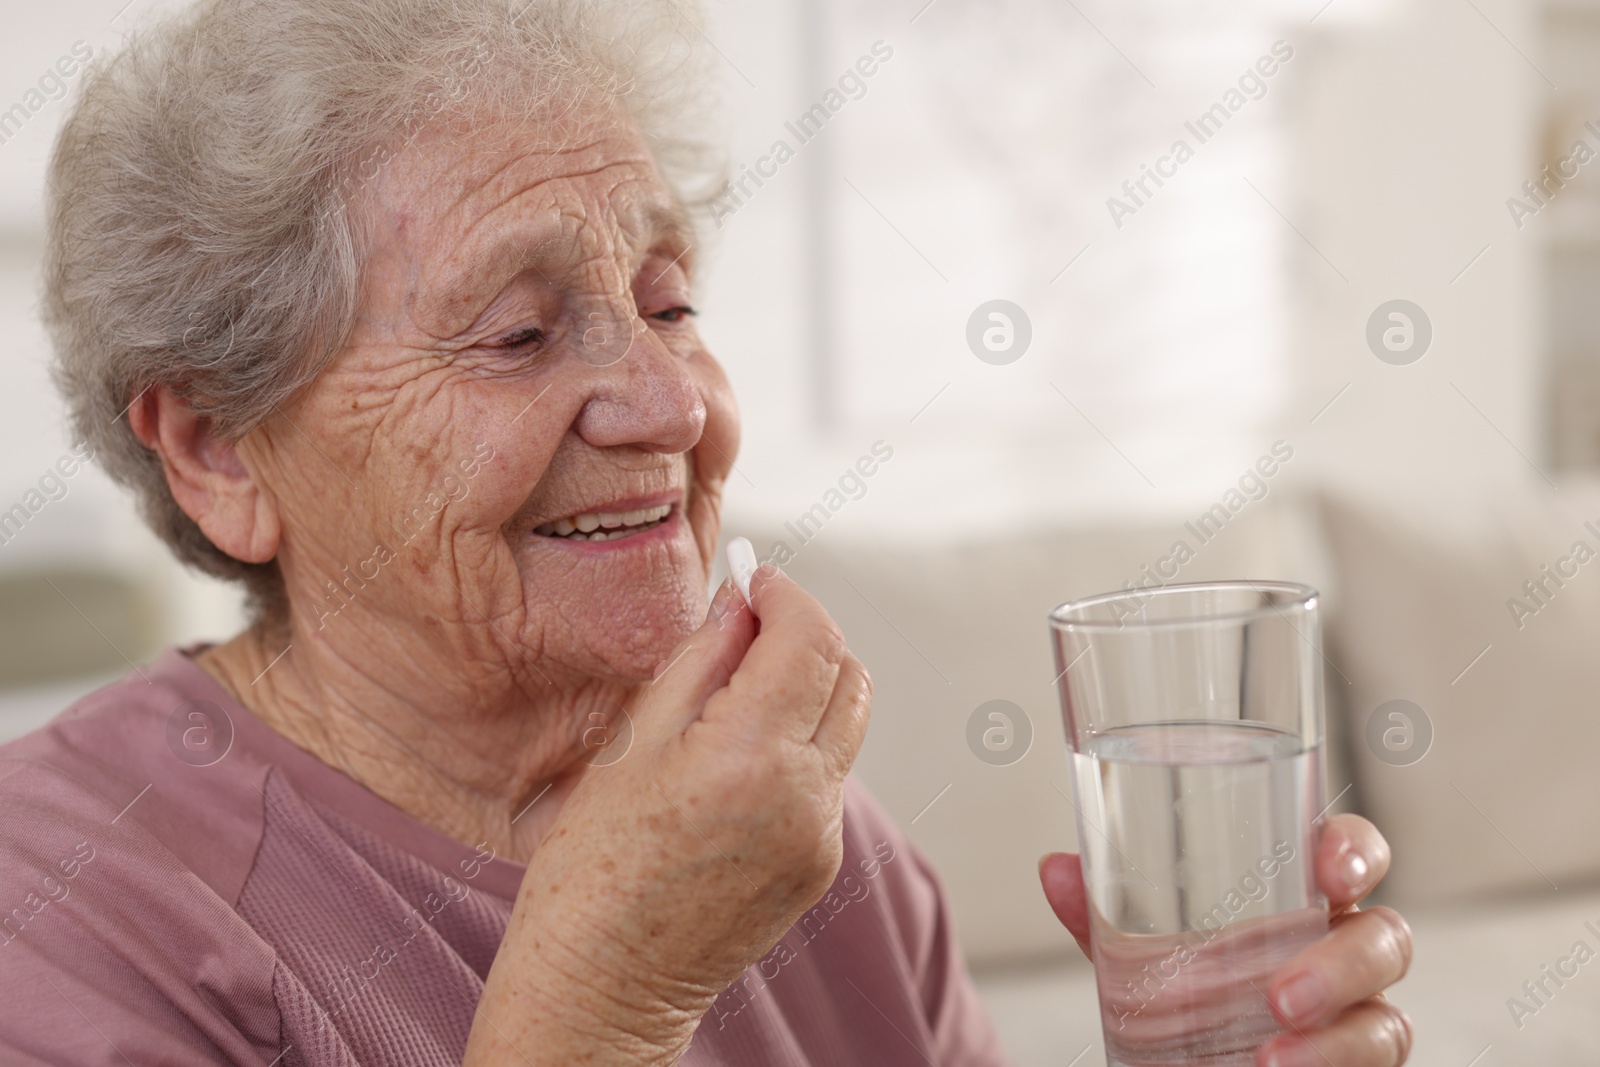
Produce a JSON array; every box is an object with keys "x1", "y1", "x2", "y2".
[{"x1": 0, "y1": 649, "x2": 1006, "y2": 1067}]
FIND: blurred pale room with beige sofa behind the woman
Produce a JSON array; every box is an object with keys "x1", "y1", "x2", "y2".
[{"x1": 0, "y1": 0, "x2": 1600, "y2": 1067}]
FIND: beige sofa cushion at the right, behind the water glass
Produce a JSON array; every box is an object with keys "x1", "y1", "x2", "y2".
[{"x1": 1325, "y1": 486, "x2": 1600, "y2": 901}]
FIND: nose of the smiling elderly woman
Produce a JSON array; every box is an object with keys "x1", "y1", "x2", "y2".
[{"x1": 573, "y1": 314, "x2": 706, "y2": 453}]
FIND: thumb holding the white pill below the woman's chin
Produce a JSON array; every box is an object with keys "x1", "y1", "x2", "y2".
[{"x1": 635, "y1": 581, "x2": 757, "y2": 731}]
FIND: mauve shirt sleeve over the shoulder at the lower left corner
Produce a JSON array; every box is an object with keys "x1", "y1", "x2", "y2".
[{"x1": 0, "y1": 758, "x2": 280, "y2": 1067}]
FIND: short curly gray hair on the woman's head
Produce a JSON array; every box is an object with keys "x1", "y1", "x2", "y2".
[{"x1": 43, "y1": 0, "x2": 726, "y2": 619}]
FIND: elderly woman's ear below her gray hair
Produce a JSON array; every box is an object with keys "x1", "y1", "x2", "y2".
[{"x1": 128, "y1": 386, "x2": 282, "y2": 563}]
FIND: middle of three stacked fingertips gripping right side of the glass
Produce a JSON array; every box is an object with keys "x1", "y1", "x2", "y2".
[{"x1": 1267, "y1": 907, "x2": 1411, "y2": 1029}]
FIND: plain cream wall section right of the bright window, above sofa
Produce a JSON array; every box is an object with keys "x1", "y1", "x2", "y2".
[{"x1": 1282, "y1": 0, "x2": 1552, "y2": 507}]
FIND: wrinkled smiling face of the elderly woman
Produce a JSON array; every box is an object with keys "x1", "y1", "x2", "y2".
[{"x1": 254, "y1": 114, "x2": 738, "y2": 681}]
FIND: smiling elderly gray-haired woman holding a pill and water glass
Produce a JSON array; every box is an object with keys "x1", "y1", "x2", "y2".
[{"x1": 0, "y1": 0, "x2": 1410, "y2": 1067}]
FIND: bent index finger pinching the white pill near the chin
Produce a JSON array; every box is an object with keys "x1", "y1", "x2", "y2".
[{"x1": 706, "y1": 565, "x2": 850, "y2": 742}]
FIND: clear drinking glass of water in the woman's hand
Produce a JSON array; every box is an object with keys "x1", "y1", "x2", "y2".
[{"x1": 1050, "y1": 581, "x2": 1328, "y2": 1067}]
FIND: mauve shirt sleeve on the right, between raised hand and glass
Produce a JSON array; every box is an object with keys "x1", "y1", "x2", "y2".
[{"x1": 845, "y1": 777, "x2": 1011, "y2": 1067}]
